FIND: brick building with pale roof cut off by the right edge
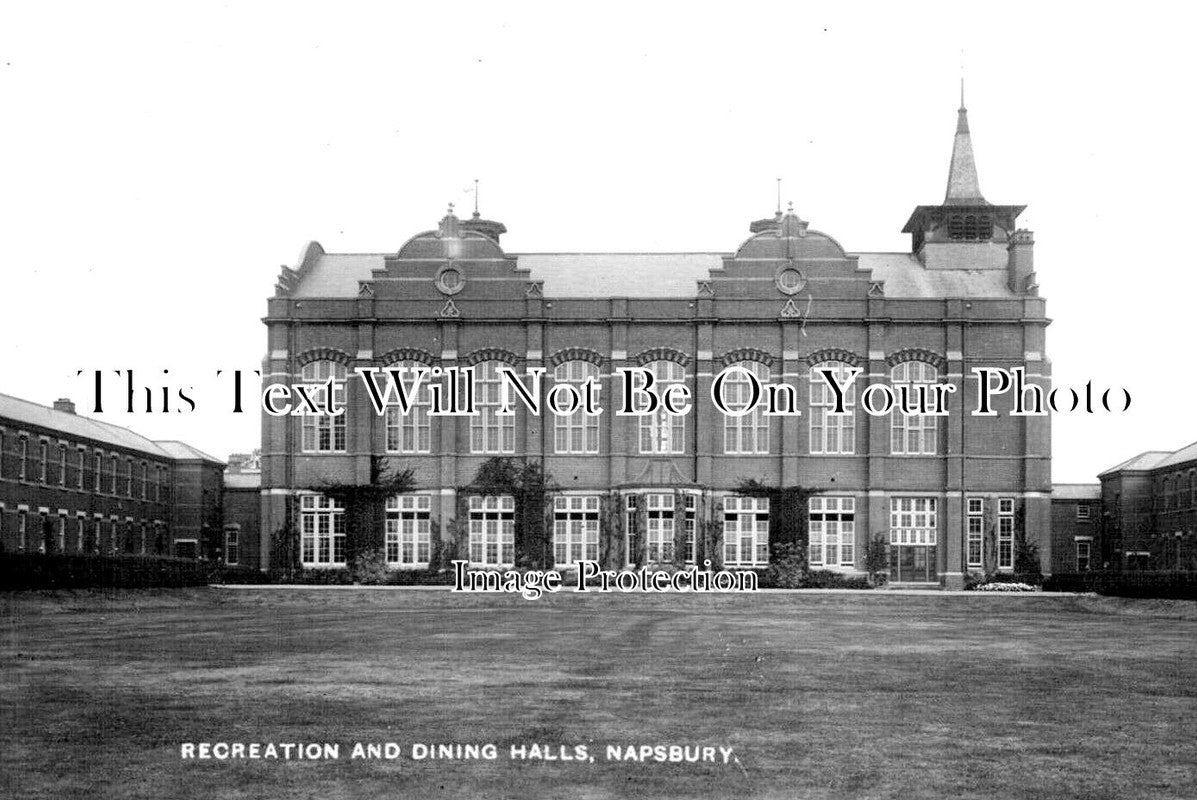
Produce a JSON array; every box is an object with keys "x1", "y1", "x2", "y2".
[{"x1": 1098, "y1": 442, "x2": 1197, "y2": 570}]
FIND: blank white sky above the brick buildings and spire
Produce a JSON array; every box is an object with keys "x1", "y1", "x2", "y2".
[{"x1": 0, "y1": 2, "x2": 1197, "y2": 481}]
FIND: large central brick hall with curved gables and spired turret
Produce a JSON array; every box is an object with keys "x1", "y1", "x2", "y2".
[{"x1": 261, "y1": 101, "x2": 1051, "y2": 588}]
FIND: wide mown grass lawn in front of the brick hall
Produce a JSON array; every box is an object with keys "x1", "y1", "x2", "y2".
[{"x1": 0, "y1": 589, "x2": 1197, "y2": 800}]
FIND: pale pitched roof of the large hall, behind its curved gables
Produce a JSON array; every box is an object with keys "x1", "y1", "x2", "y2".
[{"x1": 284, "y1": 253, "x2": 1014, "y2": 299}]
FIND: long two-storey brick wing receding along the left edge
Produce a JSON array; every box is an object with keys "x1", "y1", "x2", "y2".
[{"x1": 0, "y1": 394, "x2": 224, "y2": 558}]
